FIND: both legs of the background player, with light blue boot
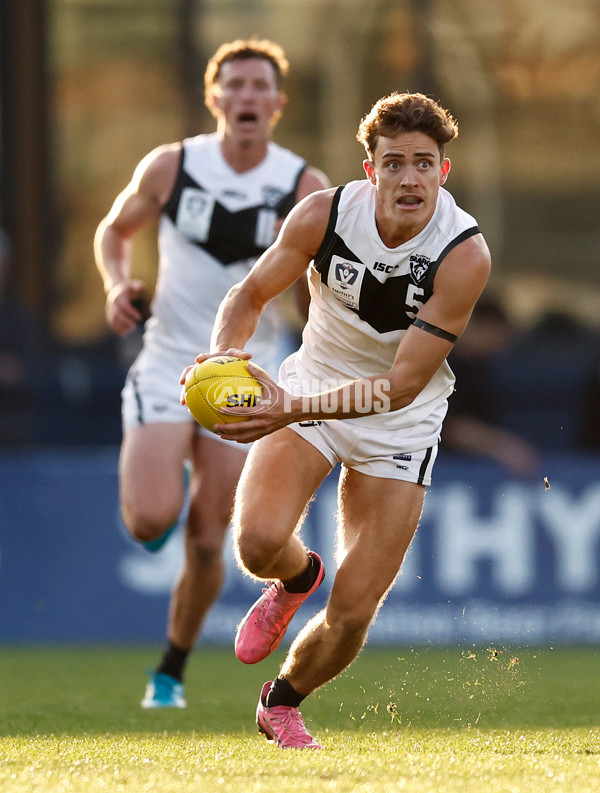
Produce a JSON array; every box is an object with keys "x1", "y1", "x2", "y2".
[{"x1": 120, "y1": 422, "x2": 246, "y2": 708}]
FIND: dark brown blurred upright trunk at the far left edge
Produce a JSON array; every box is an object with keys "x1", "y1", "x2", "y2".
[{"x1": 0, "y1": 0, "x2": 57, "y2": 332}]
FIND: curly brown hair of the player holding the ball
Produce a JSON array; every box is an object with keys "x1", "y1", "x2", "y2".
[{"x1": 356, "y1": 92, "x2": 458, "y2": 160}]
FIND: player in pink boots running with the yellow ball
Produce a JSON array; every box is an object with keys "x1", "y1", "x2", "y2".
[{"x1": 181, "y1": 93, "x2": 490, "y2": 748}]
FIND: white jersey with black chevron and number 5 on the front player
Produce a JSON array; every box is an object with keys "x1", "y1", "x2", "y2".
[{"x1": 280, "y1": 179, "x2": 479, "y2": 430}]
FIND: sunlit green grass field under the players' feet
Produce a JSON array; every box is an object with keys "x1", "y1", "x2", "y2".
[{"x1": 0, "y1": 645, "x2": 600, "y2": 793}]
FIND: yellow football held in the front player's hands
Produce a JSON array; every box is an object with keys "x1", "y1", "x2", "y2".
[{"x1": 184, "y1": 355, "x2": 268, "y2": 432}]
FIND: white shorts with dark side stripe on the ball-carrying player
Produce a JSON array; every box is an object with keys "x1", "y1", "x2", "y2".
[{"x1": 288, "y1": 419, "x2": 439, "y2": 486}]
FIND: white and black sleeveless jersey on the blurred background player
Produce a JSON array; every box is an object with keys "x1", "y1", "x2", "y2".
[{"x1": 134, "y1": 134, "x2": 306, "y2": 372}]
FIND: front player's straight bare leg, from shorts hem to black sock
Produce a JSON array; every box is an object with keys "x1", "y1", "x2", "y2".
[{"x1": 280, "y1": 470, "x2": 425, "y2": 696}]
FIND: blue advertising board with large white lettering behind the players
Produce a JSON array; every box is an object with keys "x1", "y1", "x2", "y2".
[{"x1": 0, "y1": 447, "x2": 600, "y2": 644}]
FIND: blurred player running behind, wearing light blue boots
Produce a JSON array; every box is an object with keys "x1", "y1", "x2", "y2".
[{"x1": 94, "y1": 39, "x2": 329, "y2": 708}]
